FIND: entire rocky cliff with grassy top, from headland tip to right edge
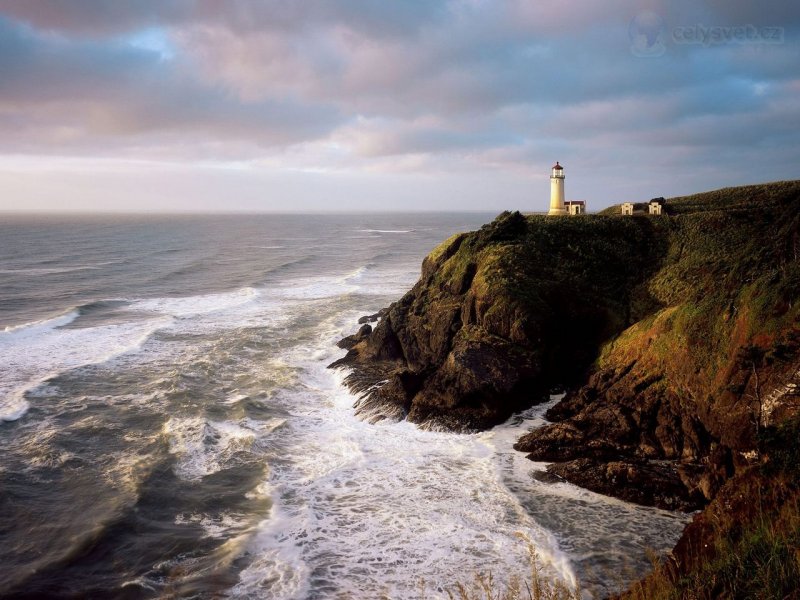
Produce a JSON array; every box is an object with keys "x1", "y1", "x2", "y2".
[{"x1": 334, "y1": 181, "x2": 800, "y2": 596}]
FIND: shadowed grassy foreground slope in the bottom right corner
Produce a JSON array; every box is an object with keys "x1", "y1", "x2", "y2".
[{"x1": 617, "y1": 415, "x2": 800, "y2": 600}]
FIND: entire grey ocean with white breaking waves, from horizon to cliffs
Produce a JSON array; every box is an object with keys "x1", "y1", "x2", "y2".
[{"x1": 0, "y1": 214, "x2": 688, "y2": 600}]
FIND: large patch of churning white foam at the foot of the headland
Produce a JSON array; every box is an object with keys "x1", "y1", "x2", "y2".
[{"x1": 232, "y1": 328, "x2": 574, "y2": 599}]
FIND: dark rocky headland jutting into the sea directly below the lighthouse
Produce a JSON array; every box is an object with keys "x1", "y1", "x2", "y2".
[{"x1": 334, "y1": 213, "x2": 666, "y2": 430}]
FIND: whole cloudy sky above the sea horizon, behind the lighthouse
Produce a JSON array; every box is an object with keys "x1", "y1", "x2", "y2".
[{"x1": 0, "y1": 0, "x2": 800, "y2": 212}]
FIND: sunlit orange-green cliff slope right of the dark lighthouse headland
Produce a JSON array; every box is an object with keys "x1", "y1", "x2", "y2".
[{"x1": 517, "y1": 182, "x2": 800, "y2": 508}]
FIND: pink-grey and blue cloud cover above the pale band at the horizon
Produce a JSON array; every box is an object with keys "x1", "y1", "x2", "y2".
[{"x1": 0, "y1": 0, "x2": 800, "y2": 211}]
